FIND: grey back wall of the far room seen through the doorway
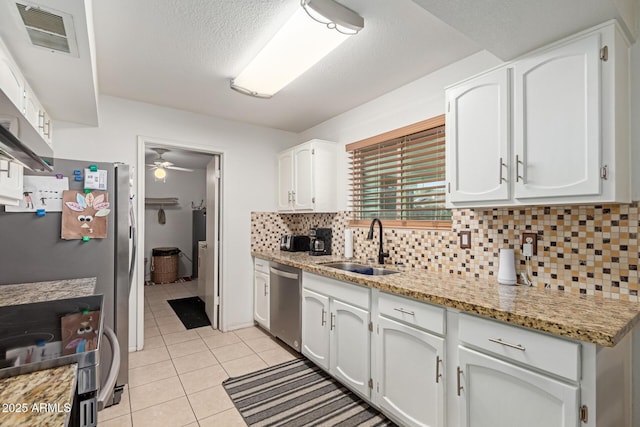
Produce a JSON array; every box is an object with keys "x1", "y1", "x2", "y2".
[{"x1": 144, "y1": 169, "x2": 206, "y2": 277}]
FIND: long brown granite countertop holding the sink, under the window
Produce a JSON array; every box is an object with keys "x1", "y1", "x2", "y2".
[{"x1": 252, "y1": 251, "x2": 640, "y2": 347}]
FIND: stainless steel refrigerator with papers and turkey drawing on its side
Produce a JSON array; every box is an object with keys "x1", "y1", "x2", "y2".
[{"x1": 0, "y1": 159, "x2": 136, "y2": 406}]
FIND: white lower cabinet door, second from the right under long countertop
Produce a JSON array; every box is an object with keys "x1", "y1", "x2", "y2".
[{"x1": 374, "y1": 316, "x2": 445, "y2": 427}]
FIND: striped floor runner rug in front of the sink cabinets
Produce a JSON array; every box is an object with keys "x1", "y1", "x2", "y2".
[{"x1": 222, "y1": 359, "x2": 395, "y2": 427}]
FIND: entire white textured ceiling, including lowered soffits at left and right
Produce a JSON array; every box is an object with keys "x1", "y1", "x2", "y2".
[{"x1": 0, "y1": 0, "x2": 640, "y2": 132}]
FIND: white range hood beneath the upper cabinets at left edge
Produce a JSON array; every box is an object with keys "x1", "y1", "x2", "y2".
[{"x1": 0, "y1": 89, "x2": 53, "y2": 172}]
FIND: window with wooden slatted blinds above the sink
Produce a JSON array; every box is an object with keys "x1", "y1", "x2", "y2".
[{"x1": 347, "y1": 115, "x2": 451, "y2": 229}]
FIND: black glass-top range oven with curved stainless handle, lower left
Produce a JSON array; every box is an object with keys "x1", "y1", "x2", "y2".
[{"x1": 0, "y1": 295, "x2": 120, "y2": 427}]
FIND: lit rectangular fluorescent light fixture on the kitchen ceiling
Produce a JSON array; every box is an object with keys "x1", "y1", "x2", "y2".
[{"x1": 231, "y1": 0, "x2": 364, "y2": 98}]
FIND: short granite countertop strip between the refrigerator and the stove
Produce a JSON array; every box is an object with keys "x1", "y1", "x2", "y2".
[{"x1": 0, "y1": 277, "x2": 96, "y2": 307}]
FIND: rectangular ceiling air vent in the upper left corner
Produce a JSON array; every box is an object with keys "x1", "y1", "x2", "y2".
[{"x1": 16, "y1": 3, "x2": 77, "y2": 56}]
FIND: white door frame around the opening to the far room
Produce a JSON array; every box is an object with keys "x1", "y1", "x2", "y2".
[{"x1": 135, "y1": 135, "x2": 225, "y2": 351}]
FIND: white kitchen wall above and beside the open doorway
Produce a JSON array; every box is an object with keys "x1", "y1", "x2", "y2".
[{"x1": 54, "y1": 96, "x2": 297, "y2": 347}]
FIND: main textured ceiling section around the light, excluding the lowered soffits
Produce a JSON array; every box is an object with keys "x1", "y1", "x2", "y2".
[{"x1": 94, "y1": 0, "x2": 479, "y2": 132}]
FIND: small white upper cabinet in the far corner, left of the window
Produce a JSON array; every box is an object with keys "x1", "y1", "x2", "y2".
[{"x1": 277, "y1": 139, "x2": 337, "y2": 212}]
